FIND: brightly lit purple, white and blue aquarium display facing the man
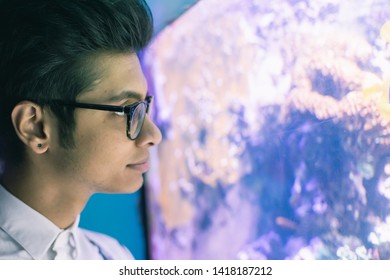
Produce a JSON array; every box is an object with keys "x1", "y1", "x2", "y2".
[{"x1": 144, "y1": 0, "x2": 390, "y2": 259}]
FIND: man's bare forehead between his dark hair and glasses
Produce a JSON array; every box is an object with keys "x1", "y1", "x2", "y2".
[{"x1": 78, "y1": 53, "x2": 147, "y2": 102}]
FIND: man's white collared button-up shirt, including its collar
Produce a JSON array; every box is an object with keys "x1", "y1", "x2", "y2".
[{"x1": 0, "y1": 185, "x2": 134, "y2": 260}]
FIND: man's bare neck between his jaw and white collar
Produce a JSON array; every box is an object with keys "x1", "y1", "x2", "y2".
[{"x1": 1, "y1": 161, "x2": 91, "y2": 229}]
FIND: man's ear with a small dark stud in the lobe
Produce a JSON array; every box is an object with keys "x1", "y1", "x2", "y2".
[{"x1": 11, "y1": 101, "x2": 48, "y2": 154}]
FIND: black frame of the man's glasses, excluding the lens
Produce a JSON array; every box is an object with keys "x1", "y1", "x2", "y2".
[{"x1": 53, "y1": 95, "x2": 153, "y2": 140}]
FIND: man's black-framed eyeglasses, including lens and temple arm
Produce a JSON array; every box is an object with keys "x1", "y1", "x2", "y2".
[{"x1": 54, "y1": 96, "x2": 152, "y2": 140}]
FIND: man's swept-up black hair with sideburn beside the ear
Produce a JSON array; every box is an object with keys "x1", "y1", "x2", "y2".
[{"x1": 0, "y1": 0, "x2": 153, "y2": 164}]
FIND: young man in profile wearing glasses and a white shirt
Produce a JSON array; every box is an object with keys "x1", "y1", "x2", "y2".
[{"x1": 0, "y1": 0, "x2": 161, "y2": 259}]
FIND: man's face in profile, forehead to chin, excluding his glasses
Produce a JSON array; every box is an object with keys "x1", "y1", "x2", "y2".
[{"x1": 51, "y1": 54, "x2": 161, "y2": 196}]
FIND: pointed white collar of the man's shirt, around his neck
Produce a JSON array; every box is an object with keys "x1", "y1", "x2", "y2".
[{"x1": 0, "y1": 185, "x2": 62, "y2": 259}]
